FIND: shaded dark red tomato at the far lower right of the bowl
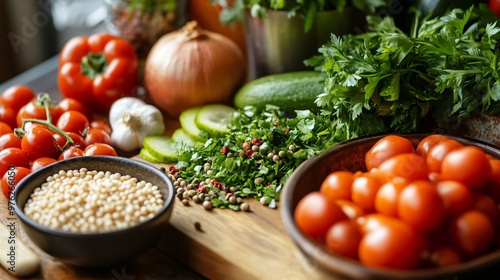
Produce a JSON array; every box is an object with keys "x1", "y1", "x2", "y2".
[{"x1": 450, "y1": 210, "x2": 495, "y2": 257}]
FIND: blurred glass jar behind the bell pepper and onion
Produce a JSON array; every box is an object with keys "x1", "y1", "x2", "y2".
[{"x1": 104, "y1": 0, "x2": 189, "y2": 59}]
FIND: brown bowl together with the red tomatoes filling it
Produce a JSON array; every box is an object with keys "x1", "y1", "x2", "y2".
[{"x1": 280, "y1": 134, "x2": 500, "y2": 279}]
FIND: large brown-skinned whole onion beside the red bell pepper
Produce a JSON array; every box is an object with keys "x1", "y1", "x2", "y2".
[{"x1": 144, "y1": 21, "x2": 247, "y2": 117}]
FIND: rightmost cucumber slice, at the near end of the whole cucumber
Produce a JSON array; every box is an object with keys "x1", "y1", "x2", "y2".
[{"x1": 194, "y1": 104, "x2": 236, "y2": 138}]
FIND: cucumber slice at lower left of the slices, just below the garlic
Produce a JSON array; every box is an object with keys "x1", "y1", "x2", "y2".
[{"x1": 144, "y1": 135, "x2": 178, "y2": 163}]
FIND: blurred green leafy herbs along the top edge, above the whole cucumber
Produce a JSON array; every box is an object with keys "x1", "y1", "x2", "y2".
[{"x1": 210, "y1": 0, "x2": 389, "y2": 32}]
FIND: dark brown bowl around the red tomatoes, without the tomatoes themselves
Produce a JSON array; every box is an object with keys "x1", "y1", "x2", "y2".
[{"x1": 280, "y1": 134, "x2": 500, "y2": 279}]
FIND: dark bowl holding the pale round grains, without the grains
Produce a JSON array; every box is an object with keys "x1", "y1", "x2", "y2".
[{"x1": 15, "y1": 156, "x2": 175, "y2": 267}]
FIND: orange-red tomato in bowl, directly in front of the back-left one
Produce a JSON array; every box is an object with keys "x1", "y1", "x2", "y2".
[{"x1": 378, "y1": 153, "x2": 429, "y2": 182}]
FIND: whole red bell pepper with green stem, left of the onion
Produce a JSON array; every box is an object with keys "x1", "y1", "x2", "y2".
[{"x1": 57, "y1": 33, "x2": 139, "y2": 112}]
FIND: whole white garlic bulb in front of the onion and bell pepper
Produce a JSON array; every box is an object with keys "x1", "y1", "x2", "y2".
[{"x1": 109, "y1": 97, "x2": 165, "y2": 152}]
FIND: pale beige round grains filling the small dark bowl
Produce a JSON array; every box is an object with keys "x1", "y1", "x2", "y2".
[{"x1": 24, "y1": 168, "x2": 164, "y2": 232}]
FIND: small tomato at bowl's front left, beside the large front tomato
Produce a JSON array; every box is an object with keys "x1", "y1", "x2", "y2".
[{"x1": 325, "y1": 220, "x2": 363, "y2": 259}]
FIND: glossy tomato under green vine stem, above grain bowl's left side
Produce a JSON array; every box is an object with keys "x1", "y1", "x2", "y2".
[{"x1": 21, "y1": 127, "x2": 60, "y2": 160}]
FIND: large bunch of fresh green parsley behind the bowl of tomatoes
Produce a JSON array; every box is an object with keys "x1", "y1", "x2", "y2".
[{"x1": 307, "y1": 5, "x2": 500, "y2": 136}]
